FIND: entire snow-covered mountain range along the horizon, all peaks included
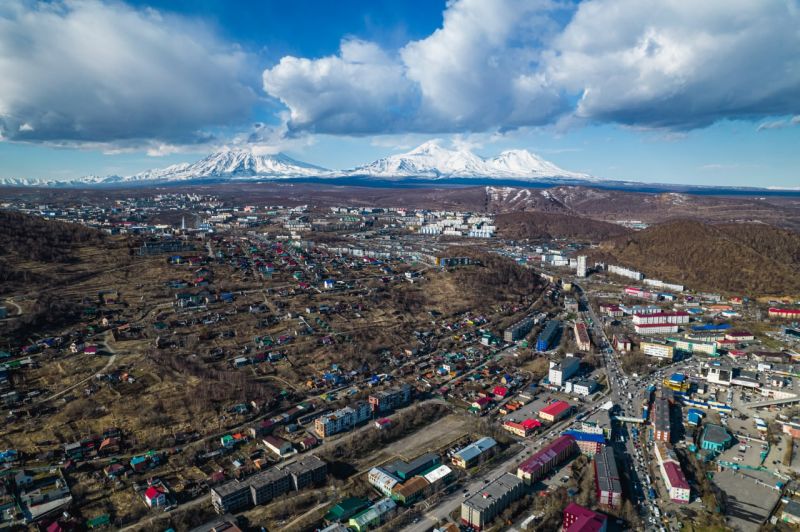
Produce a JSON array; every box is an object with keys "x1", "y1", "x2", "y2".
[{"x1": 0, "y1": 141, "x2": 596, "y2": 187}]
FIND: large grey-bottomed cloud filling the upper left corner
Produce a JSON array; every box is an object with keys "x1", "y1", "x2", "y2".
[{"x1": 0, "y1": 0, "x2": 258, "y2": 146}]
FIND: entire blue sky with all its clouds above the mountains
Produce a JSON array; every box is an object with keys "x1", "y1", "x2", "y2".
[{"x1": 0, "y1": 0, "x2": 800, "y2": 187}]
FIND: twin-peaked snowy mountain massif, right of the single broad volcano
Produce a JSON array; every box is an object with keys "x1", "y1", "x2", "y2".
[{"x1": 347, "y1": 141, "x2": 592, "y2": 180}]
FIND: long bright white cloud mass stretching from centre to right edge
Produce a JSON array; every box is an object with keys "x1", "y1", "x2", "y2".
[{"x1": 263, "y1": 0, "x2": 800, "y2": 134}]
